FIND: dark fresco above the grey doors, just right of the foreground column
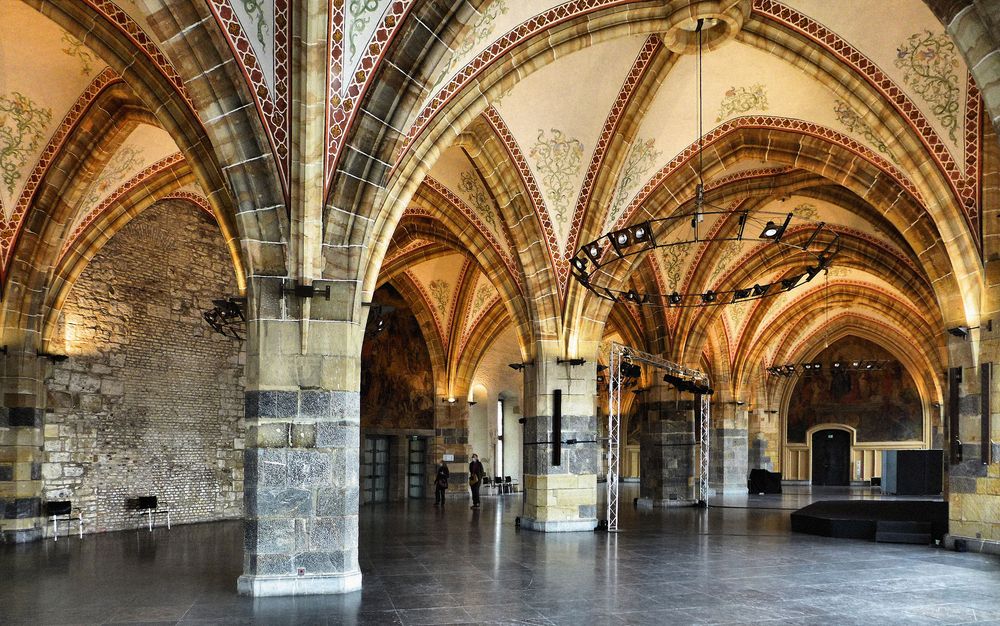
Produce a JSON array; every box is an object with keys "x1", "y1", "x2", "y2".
[{"x1": 361, "y1": 286, "x2": 434, "y2": 430}]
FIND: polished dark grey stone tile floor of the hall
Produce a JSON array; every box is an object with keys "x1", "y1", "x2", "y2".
[{"x1": 0, "y1": 486, "x2": 1000, "y2": 626}]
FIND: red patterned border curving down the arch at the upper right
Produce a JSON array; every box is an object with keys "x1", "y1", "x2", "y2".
[{"x1": 753, "y1": 0, "x2": 982, "y2": 240}]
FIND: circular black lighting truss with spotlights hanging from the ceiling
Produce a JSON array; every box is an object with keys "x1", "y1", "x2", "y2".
[{"x1": 570, "y1": 210, "x2": 840, "y2": 308}]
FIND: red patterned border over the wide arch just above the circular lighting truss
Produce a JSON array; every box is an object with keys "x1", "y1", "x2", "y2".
[{"x1": 612, "y1": 116, "x2": 923, "y2": 230}]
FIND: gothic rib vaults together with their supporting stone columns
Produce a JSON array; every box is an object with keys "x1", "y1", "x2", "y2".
[{"x1": 0, "y1": 0, "x2": 1000, "y2": 594}]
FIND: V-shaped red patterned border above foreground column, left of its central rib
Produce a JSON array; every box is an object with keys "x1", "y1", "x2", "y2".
[{"x1": 206, "y1": 0, "x2": 291, "y2": 195}]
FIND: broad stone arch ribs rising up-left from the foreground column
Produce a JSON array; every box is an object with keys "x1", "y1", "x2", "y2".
[{"x1": 46, "y1": 0, "x2": 288, "y2": 276}]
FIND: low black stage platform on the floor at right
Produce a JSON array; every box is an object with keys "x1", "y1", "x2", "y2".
[{"x1": 792, "y1": 500, "x2": 948, "y2": 544}]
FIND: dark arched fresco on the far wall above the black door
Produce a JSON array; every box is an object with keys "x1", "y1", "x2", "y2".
[{"x1": 788, "y1": 337, "x2": 923, "y2": 443}]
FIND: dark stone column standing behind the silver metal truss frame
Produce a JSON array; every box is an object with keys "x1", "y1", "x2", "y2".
[{"x1": 639, "y1": 378, "x2": 698, "y2": 507}]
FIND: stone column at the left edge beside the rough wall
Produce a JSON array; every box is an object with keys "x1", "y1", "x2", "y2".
[{"x1": 0, "y1": 347, "x2": 48, "y2": 543}]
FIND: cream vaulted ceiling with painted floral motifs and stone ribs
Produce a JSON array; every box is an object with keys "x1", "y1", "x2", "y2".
[{"x1": 0, "y1": 0, "x2": 984, "y2": 402}]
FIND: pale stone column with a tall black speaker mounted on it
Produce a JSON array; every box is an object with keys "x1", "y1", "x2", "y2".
[{"x1": 521, "y1": 354, "x2": 600, "y2": 532}]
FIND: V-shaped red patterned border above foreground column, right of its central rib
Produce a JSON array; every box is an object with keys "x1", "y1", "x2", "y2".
[{"x1": 323, "y1": 0, "x2": 416, "y2": 191}]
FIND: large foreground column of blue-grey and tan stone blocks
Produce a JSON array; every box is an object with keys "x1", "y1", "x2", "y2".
[{"x1": 238, "y1": 279, "x2": 364, "y2": 596}]
